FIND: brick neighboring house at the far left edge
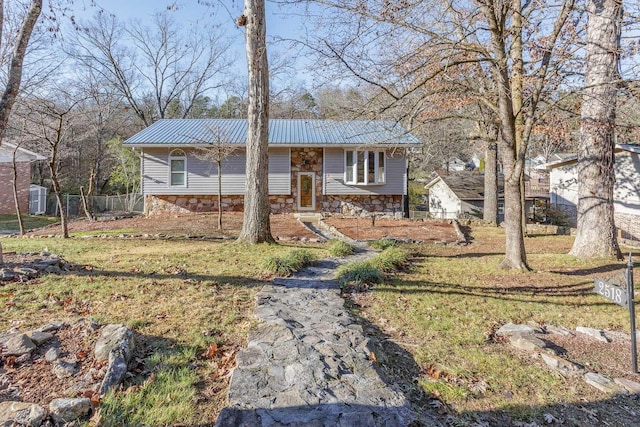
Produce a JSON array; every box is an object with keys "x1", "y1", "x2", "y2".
[{"x1": 0, "y1": 142, "x2": 45, "y2": 214}]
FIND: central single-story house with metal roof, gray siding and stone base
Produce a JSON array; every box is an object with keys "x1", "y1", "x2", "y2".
[{"x1": 125, "y1": 119, "x2": 420, "y2": 214}]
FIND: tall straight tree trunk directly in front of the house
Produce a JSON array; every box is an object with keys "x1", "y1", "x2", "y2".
[{"x1": 238, "y1": 0, "x2": 274, "y2": 244}]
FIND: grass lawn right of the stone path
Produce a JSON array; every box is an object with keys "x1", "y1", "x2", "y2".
[{"x1": 352, "y1": 227, "x2": 638, "y2": 419}]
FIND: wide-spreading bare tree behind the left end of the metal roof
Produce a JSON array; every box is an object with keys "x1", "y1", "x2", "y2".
[{"x1": 68, "y1": 13, "x2": 231, "y2": 126}]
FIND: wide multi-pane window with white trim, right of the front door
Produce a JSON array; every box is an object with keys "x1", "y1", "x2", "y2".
[{"x1": 344, "y1": 150, "x2": 386, "y2": 185}]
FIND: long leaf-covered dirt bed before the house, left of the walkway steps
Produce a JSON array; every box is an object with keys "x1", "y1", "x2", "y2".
[{"x1": 29, "y1": 212, "x2": 318, "y2": 240}]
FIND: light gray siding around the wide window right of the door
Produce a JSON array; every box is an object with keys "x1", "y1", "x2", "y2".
[{"x1": 323, "y1": 147, "x2": 407, "y2": 195}]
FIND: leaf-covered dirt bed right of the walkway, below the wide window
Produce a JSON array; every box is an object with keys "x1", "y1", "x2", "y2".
[{"x1": 325, "y1": 216, "x2": 457, "y2": 242}]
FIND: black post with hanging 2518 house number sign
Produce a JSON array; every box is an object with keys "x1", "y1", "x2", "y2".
[{"x1": 593, "y1": 253, "x2": 638, "y2": 374}]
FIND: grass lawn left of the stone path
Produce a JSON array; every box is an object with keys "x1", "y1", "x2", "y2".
[{"x1": 0, "y1": 238, "x2": 327, "y2": 426}]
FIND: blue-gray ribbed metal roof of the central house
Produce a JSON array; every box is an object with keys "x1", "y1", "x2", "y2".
[{"x1": 124, "y1": 119, "x2": 420, "y2": 146}]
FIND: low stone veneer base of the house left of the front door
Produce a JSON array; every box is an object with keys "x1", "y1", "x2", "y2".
[{"x1": 144, "y1": 195, "x2": 294, "y2": 215}]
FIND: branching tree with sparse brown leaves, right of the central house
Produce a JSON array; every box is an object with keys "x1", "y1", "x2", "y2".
[{"x1": 298, "y1": 0, "x2": 580, "y2": 269}]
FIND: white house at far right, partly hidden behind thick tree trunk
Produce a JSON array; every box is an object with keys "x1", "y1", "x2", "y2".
[{"x1": 545, "y1": 144, "x2": 640, "y2": 241}]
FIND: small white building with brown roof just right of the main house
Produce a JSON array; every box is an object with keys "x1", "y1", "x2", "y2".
[{"x1": 424, "y1": 172, "x2": 548, "y2": 222}]
